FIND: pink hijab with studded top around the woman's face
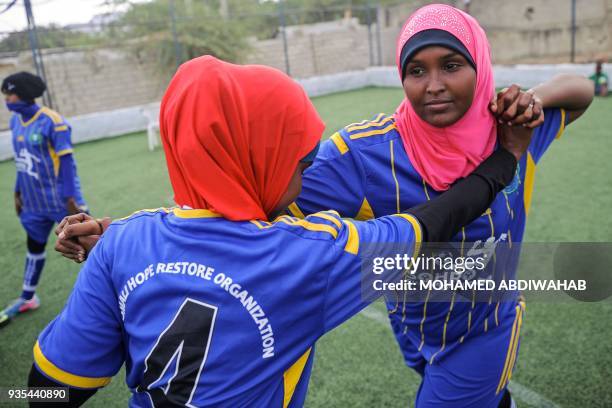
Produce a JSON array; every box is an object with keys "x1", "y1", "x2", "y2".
[{"x1": 395, "y1": 4, "x2": 496, "y2": 191}]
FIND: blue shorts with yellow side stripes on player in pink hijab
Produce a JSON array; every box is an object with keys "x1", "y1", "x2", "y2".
[{"x1": 389, "y1": 302, "x2": 524, "y2": 408}]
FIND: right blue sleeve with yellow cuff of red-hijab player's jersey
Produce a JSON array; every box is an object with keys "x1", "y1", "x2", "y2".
[{"x1": 320, "y1": 214, "x2": 422, "y2": 331}]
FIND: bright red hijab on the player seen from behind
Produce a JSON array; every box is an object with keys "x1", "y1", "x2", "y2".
[{"x1": 159, "y1": 56, "x2": 325, "y2": 221}]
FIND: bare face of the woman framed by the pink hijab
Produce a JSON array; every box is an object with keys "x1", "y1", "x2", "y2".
[{"x1": 403, "y1": 46, "x2": 476, "y2": 127}]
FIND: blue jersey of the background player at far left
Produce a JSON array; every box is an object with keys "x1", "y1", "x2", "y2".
[{"x1": 10, "y1": 107, "x2": 85, "y2": 213}]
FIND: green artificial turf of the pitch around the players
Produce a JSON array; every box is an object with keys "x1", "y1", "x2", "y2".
[{"x1": 0, "y1": 88, "x2": 612, "y2": 408}]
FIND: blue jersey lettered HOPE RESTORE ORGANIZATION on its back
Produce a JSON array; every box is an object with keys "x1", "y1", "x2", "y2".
[{"x1": 34, "y1": 209, "x2": 421, "y2": 407}]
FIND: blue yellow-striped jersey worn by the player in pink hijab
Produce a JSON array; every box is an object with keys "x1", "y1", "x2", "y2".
[{"x1": 289, "y1": 109, "x2": 565, "y2": 362}]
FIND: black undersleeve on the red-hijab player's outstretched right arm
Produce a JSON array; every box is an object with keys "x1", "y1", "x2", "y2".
[{"x1": 407, "y1": 148, "x2": 517, "y2": 242}]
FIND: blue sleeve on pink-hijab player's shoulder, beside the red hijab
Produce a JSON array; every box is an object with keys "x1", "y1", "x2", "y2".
[{"x1": 289, "y1": 133, "x2": 366, "y2": 218}]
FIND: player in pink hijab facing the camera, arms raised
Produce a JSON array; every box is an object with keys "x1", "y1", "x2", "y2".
[{"x1": 289, "y1": 4, "x2": 593, "y2": 408}]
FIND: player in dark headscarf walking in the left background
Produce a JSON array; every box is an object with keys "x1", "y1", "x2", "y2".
[{"x1": 0, "y1": 72, "x2": 86, "y2": 326}]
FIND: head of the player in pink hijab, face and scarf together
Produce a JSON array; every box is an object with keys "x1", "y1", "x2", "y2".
[{"x1": 395, "y1": 5, "x2": 496, "y2": 191}]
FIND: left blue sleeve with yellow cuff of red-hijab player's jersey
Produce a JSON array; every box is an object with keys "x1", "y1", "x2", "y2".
[{"x1": 34, "y1": 237, "x2": 124, "y2": 388}]
